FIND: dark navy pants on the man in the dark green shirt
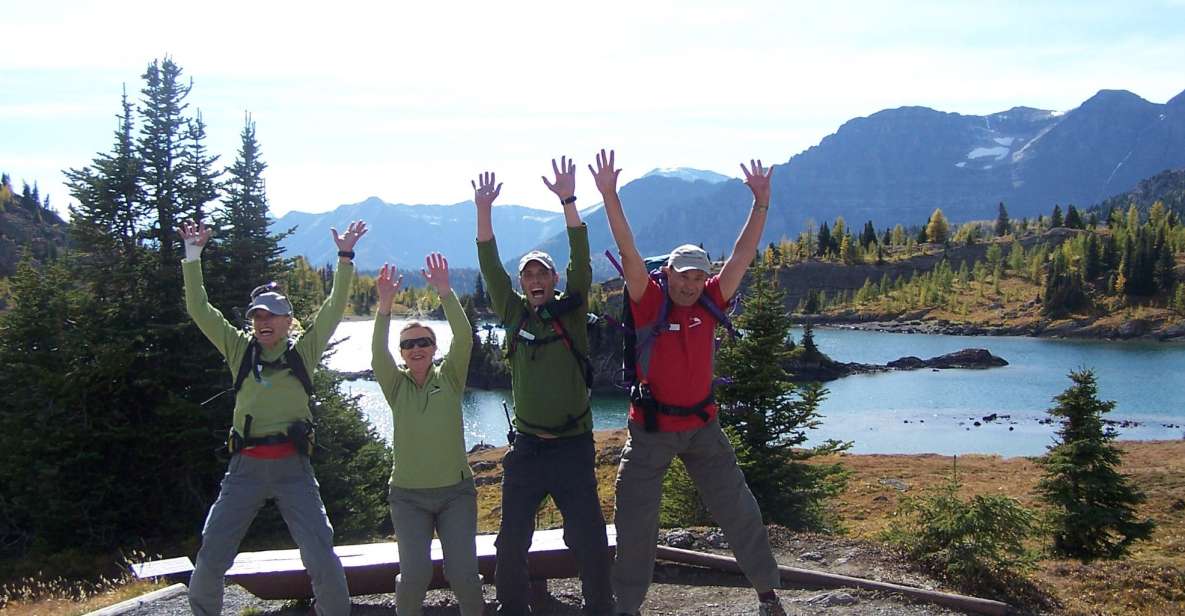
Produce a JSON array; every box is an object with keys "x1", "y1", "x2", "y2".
[{"x1": 494, "y1": 432, "x2": 613, "y2": 616}]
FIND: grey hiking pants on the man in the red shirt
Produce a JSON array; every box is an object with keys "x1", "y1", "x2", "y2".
[{"x1": 613, "y1": 418, "x2": 781, "y2": 614}]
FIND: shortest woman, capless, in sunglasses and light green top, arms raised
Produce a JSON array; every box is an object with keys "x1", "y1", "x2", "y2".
[{"x1": 371, "y1": 252, "x2": 483, "y2": 616}]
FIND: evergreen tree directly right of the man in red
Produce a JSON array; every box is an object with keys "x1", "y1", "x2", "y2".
[{"x1": 717, "y1": 263, "x2": 848, "y2": 528}]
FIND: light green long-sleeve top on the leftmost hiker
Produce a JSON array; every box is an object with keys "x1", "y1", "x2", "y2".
[{"x1": 181, "y1": 259, "x2": 354, "y2": 438}]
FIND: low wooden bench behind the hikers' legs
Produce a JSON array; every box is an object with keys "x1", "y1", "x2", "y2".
[{"x1": 132, "y1": 525, "x2": 617, "y2": 599}]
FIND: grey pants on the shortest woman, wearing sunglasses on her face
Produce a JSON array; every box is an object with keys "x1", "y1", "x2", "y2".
[{"x1": 387, "y1": 479, "x2": 485, "y2": 616}]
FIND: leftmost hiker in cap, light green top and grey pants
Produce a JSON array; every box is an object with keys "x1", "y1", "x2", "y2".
[{"x1": 179, "y1": 222, "x2": 366, "y2": 616}]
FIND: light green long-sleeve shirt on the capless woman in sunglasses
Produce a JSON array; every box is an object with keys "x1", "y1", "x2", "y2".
[{"x1": 371, "y1": 293, "x2": 473, "y2": 489}]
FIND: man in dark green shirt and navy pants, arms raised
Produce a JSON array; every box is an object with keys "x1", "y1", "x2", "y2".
[{"x1": 473, "y1": 161, "x2": 613, "y2": 616}]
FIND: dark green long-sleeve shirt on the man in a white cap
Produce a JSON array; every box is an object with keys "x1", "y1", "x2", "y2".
[{"x1": 478, "y1": 225, "x2": 593, "y2": 436}]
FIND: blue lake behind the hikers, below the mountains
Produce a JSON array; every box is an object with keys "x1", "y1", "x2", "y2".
[{"x1": 328, "y1": 321, "x2": 1185, "y2": 456}]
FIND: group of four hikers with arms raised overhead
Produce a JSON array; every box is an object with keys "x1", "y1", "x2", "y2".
[{"x1": 179, "y1": 149, "x2": 784, "y2": 616}]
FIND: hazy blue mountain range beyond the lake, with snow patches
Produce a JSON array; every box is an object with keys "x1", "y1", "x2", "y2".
[{"x1": 276, "y1": 90, "x2": 1185, "y2": 274}]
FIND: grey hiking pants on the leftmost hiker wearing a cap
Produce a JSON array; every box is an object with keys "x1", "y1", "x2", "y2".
[{"x1": 190, "y1": 454, "x2": 350, "y2": 616}]
